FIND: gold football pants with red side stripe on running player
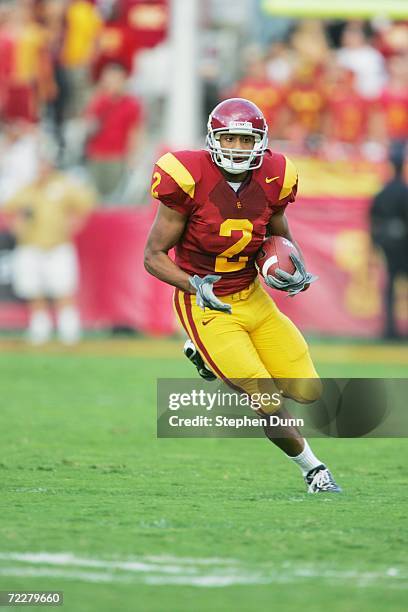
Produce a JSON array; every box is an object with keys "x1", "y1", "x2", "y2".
[{"x1": 174, "y1": 280, "x2": 320, "y2": 403}]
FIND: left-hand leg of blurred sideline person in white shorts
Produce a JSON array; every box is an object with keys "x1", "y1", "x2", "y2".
[{"x1": 12, "y1": 246, "x2": 52, "y2": 344}]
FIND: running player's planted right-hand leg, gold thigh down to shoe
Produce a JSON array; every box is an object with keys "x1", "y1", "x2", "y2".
[{"x1": 250, "y1": 288, "x2": 340, "y2": 493}]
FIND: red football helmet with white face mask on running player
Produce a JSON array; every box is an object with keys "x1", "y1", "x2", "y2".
[{"x1": 206, "y1": 98, "x2": 268, "y2": 174}]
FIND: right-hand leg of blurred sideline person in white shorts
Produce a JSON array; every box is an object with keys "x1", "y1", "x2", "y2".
[{"x1": 45, "y1": 244, "x2": 81, "y2": 344}]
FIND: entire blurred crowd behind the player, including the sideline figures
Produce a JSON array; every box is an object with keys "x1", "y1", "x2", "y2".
[{"x1": 0, "y1": 0, "x2": 408, "y2": 344}]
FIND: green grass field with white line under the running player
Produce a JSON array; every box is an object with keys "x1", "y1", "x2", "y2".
[{"x1": 0, "y1": 341, "x2": 408, "y2": 612}]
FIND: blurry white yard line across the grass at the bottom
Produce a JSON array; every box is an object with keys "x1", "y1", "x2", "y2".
[{"x1": 0, "y1": 552, "x2": 408, "y2": 589}]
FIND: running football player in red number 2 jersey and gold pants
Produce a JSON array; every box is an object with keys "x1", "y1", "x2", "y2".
[{"x1": 145, "y1": 98, "x2": 340, "y2": 493}]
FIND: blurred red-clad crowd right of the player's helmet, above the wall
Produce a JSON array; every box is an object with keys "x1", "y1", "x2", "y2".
[{"x1": 224, "y1": 20, "x2": 408, "y2": 160}]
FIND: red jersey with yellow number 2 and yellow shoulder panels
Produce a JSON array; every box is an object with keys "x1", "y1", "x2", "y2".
[{"x1": 152, "y1": 150, "x2": 297, "y2": 295}]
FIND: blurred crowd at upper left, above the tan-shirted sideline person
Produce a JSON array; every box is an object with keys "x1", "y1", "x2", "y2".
[{"x1": 0, "y1": 0, "x2": 159, "y2": 204}]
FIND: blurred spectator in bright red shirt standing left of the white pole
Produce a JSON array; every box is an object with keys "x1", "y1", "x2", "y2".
[{"x1": 85, "y1": 64, "x2": 142, "y2": 197}]
